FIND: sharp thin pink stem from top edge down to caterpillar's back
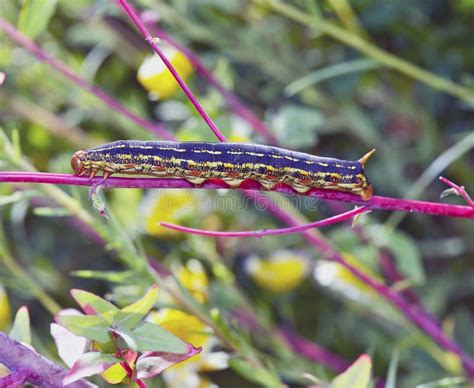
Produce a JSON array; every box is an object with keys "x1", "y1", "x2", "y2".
[{"x1": 118, "y1": 0, "x2": 227, "y2": 141}]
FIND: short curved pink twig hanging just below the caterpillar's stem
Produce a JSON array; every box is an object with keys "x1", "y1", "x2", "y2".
[{"x1": 160, "y1": 207, "x2": 369, "y2": 238}]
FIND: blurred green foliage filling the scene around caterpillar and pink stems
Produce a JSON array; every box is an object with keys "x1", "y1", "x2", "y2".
[{"x1": 0, "y1": 0, "x2": 474, "y2": 387}]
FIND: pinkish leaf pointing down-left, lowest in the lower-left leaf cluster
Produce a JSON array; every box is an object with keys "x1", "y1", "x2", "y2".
[{"x1": 63, "y1": 352, "x2": 120, "y2": 385}]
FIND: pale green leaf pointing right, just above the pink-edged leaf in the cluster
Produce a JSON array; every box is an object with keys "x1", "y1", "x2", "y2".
[{"x1": 132, "y1": 322, "x2": 188, "y2": 354}]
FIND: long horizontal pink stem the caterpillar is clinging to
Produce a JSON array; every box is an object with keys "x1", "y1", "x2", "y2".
[{"x1": 0, "y1": 171, "x2": 474, "y2": 219}]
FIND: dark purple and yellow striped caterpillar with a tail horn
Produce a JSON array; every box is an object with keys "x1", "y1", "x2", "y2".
[{"x1": 71, "y1": 140, "x2": 375, "y2": 200}]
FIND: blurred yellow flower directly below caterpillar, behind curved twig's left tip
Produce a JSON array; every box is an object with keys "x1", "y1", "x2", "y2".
[{"x1": 145, "y1": 190, "x2": 197, "y2": 237}]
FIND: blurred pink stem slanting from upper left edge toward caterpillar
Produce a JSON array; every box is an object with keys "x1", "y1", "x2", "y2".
[{"x1": 0, "y1": 16, "x2": 174, "y2": 140}]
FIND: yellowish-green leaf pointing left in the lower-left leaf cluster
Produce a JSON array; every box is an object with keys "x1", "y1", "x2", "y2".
[{"x1": 58, "y1": 315, "x2": 110, "y2": 343}]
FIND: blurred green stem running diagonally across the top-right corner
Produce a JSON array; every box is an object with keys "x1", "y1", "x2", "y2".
[{"x1": 260, "y1": 0, "x2": 474, "y2": 104}]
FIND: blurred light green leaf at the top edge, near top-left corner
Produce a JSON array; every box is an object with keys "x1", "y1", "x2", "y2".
[{"x1": 18, "y1": 0, "x2": 57, "y2": 39}]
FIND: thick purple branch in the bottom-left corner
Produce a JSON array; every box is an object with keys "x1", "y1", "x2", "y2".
[{"x1": 0, "y1": 332, "x2": 94, "y2": 388}]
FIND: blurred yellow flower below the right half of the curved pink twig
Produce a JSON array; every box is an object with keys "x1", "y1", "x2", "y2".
[{"x1": 246, "y1": 250, "x2": 308, "y2": 293}]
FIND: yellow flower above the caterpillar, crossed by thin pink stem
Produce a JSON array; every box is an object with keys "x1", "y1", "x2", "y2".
[{"x1": 137, "y1": 45, "x2": 193, "y2": 100}]
